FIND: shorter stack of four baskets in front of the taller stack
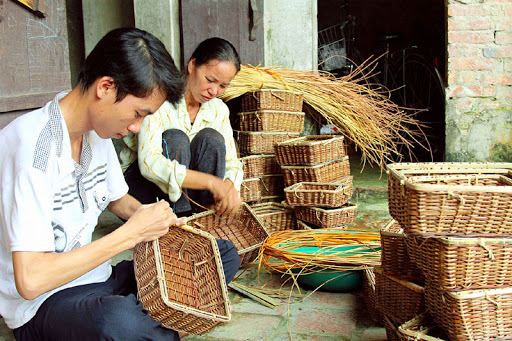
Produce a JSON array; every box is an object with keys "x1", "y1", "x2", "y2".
[{"x1": 275, "y1": 135, "x2": 356, "y2": 228}]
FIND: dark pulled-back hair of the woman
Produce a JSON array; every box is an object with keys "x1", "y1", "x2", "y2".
[{"x1": 189, "y1": 37, "x2": 240, "y2": 72}]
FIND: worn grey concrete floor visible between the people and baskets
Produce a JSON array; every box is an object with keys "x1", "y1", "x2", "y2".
[{"x1": 0, "y1": 157, "x2": 390, "y2": 341}]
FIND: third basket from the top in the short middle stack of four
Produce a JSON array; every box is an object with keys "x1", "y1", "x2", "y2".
[{"x1": 284, "y1": 182, "x2": 352, "y2": 207}]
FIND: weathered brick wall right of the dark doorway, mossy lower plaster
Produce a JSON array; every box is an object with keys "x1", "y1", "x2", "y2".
[{"x1": 446, "y1": 0, "x2": 512, "y2": 162}]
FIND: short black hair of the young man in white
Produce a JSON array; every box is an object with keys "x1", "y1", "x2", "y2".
[{"x1": 78, "y1": 28, "x2": 185, "y2": 104}]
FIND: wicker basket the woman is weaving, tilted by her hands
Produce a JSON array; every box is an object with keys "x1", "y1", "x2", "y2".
[{"x1": 188, "y1": 203, "x2": 268, "y2": 266}]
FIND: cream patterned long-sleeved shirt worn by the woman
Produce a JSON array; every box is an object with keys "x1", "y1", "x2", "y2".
[{"x1": 120, "y1": 97, "x2": 243, "y2": 202}]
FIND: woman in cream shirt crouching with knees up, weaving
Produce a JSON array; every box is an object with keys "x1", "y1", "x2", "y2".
[{"x1": 121, "y1": 38, "x2": 243, "y2": 216}]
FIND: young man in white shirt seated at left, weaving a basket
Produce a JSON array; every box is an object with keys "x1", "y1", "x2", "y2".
[{"x1": 0, "y1": 28, "x2": 238, "y2": 340}]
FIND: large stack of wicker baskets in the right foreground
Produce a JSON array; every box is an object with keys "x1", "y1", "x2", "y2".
[{"x1": 384, "y1": 163, "x2": 512, "y2": 340}]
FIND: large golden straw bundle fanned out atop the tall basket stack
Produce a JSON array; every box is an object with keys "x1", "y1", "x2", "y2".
[{"x1": 221, "y1": 62, "x2": 424, "y2": 168}]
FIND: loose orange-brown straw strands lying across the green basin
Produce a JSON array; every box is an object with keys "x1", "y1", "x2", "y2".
[{"x1": 258, "y1": 229, "x2": 380, "y2": 274}]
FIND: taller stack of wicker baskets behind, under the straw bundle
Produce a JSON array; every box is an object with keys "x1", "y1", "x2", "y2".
[{"x1": 237, "y1": 89, "x2": 304, "y2": 203}]
